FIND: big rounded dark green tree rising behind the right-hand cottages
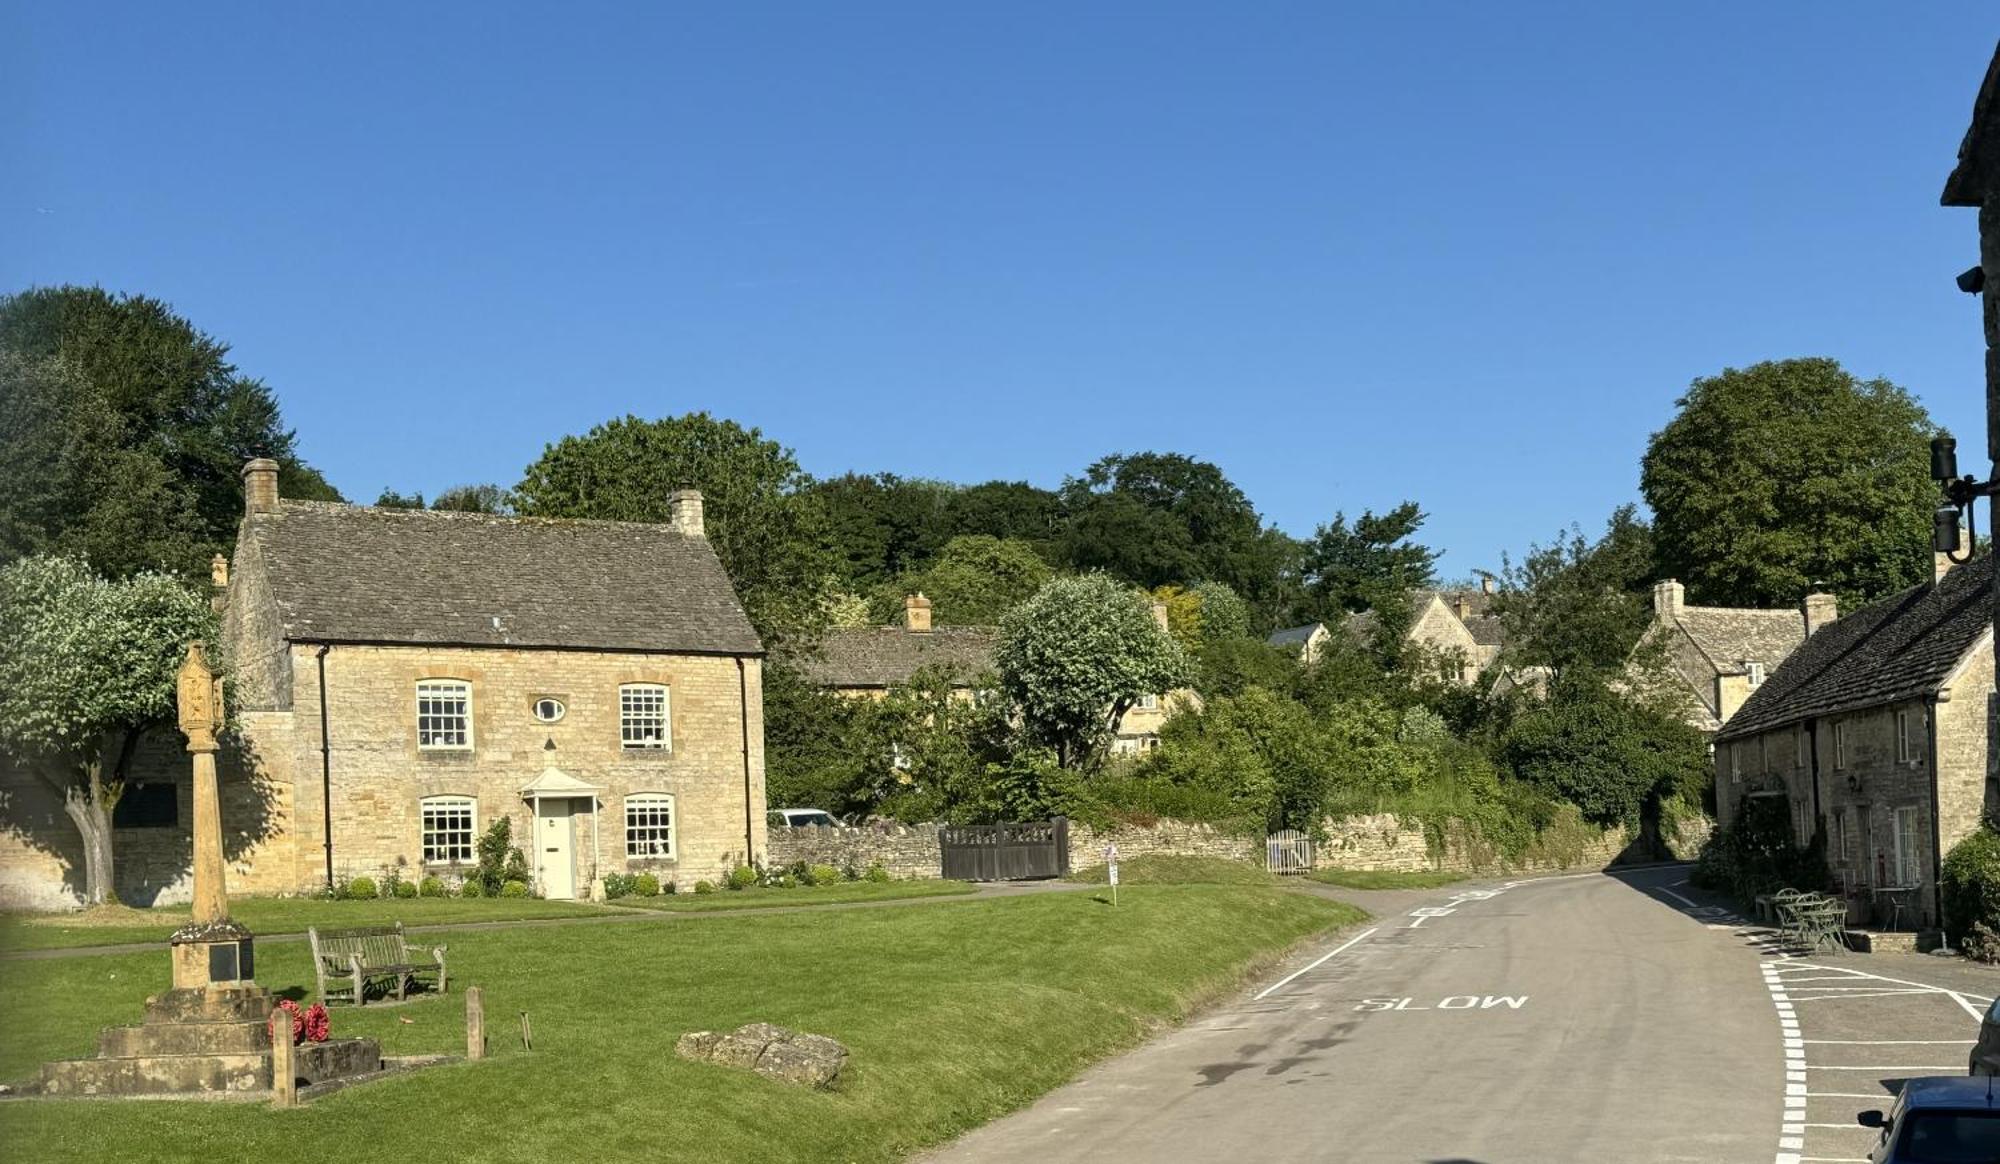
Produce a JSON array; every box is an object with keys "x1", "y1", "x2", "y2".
[{"x1": 1640, "y1": 358, "x2": 1938, "y2": 606}]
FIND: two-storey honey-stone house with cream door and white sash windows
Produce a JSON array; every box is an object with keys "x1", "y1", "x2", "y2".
[{"x1": 0, "y1": 460, "x2": 764, "y2": 906}]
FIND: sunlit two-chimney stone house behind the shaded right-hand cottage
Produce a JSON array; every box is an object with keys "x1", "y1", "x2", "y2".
[{"x1": 1626, "y1": 578, "x2": 1838, "y2": 736}]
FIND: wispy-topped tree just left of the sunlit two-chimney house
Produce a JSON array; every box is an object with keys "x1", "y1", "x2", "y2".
[{"x1": 1494, "y1": 506, "x2": 1654, "y2": 674}]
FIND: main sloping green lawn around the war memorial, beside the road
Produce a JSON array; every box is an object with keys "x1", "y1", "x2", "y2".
[{"x1": 0, "y1": 886, "x2": 1362, "y2": 1164}]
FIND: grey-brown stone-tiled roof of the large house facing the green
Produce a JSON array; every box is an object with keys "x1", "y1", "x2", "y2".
[{"x1": 244, "y1": 500, "x2": 764, "y2": 654}]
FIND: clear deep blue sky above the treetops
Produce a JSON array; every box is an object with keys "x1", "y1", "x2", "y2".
[{"x1": 0, "y1": 0, "x2": 2000, "y2": 576}]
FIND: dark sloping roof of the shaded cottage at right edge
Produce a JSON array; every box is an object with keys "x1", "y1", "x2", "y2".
[{"x1": 1716, "y1": 554, "x2": 1994, "y2": 740}]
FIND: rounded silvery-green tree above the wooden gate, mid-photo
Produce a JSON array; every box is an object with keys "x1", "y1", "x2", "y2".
[{"x1": 994, "y1": 574, "x2": 1190, "y2": 770}]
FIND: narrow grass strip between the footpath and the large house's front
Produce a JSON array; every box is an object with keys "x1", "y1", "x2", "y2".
[{"x1": 0, "y1": 898, "x2": 606, "y2": 950}]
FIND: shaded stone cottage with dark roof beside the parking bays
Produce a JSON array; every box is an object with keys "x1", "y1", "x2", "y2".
[{"x1": 1714, "y1": 556, "x2": 1994, "y2": 928}]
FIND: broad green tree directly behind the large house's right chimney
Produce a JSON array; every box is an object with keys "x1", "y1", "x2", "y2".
[{"x1": 514, "y1": 412, "x2": 836, "y2": 646}]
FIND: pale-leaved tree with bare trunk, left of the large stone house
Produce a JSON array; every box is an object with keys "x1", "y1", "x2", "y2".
[{"x1": 0, "y1": 558, "x2": 214, "y2": 904}]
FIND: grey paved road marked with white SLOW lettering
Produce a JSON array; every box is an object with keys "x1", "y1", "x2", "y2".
[{"x1": 932, "y1": 868, "x2": 1792, "y2": 1164}]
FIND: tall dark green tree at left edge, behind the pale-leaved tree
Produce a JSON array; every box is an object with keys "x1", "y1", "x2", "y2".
[{"x1": 0, "y1": 286, "x2": 340, "y2": 576}]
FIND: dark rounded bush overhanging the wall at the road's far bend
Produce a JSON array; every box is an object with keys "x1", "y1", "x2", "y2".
[{"x1": 1500, "y1": 676, "x2": 1708, "y2": 828}]
